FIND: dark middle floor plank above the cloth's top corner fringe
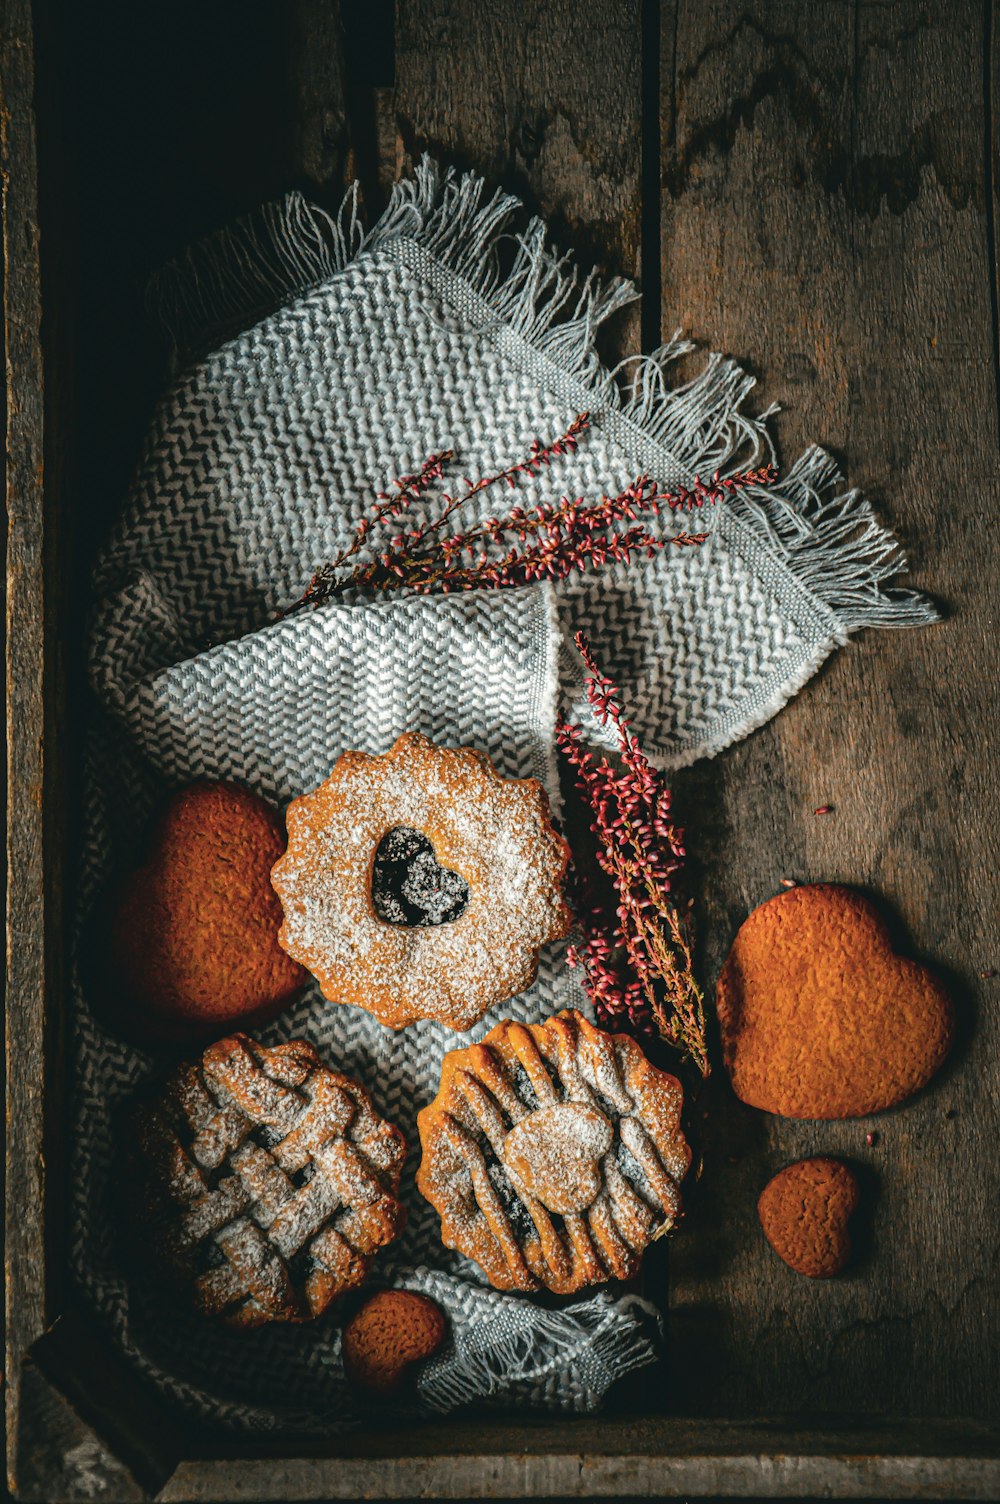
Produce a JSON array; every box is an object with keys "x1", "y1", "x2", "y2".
[{"x1": 395, "y1": 0, "x2": 642, "y2": 350}]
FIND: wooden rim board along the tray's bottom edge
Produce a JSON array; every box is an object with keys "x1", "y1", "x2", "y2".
[{"x1": 159, "y1": 1420, "x2": 1000, "y2": 1504}]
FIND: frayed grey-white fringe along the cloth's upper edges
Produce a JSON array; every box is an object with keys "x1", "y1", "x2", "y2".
[{"x1": 150, "y1": 156, "x2": 940, "y2": 632}]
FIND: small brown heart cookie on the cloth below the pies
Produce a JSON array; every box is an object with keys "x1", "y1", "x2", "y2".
[{"x1": 343, "y1": 1290, "x2": 445, "y2": 1394}]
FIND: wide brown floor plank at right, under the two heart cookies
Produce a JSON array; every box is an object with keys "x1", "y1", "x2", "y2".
[{"x1": 663, "y1": 0, "x2": 1000, "y2": 1415}]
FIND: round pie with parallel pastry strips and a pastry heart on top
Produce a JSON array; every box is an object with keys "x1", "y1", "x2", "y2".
[{"x1": 417, "y1": 1011, "x2": 690, "y2": 1295}]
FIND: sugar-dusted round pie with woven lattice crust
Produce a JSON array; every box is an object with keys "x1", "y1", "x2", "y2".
[{"x1": 134, "y1": 1035, "x2": 406, "y2": 1327}]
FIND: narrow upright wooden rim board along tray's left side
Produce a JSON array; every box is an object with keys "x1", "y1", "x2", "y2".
[{"x1": 0, "y1": 0, "x2": 45, "y2": 1478}]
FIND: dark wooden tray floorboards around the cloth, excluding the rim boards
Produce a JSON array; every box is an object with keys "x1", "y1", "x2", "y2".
[{"x1": 7, "y1": 0, "x2": 1000, "y2": 1479}]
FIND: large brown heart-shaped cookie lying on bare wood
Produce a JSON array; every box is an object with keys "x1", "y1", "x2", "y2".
[{"x1": 717, "y1": 883, "x2": 955, "y2": 1117}]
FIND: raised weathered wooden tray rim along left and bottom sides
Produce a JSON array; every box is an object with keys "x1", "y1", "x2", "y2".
[{"x1": 0, "y1": 0, "x2": 1000, "y2": 1501}]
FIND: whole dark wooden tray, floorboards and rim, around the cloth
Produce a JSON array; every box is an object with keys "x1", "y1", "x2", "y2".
[{"x1": 7, "y1": 0, "x2": 1000, "y2": 1501}]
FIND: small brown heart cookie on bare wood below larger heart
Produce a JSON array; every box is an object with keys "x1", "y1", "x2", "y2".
[{"x1": 756, "y1": 1158, "x2": 859, "y2": 1280}]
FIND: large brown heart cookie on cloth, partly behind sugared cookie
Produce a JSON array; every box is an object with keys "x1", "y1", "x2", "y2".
[{"x1": 102, "y1": 782, "x2": 308, "y2": 1044}]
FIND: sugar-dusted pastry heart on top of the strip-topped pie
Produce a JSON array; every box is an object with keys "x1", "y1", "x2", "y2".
[{"x1": 501, "y1": 1102, "x2": 615, "y2": 1214}]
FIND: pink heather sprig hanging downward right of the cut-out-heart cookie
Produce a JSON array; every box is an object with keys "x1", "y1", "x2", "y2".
[{"x1": 556, "y1": 632, "x2": 710, "y2": 1075}]
